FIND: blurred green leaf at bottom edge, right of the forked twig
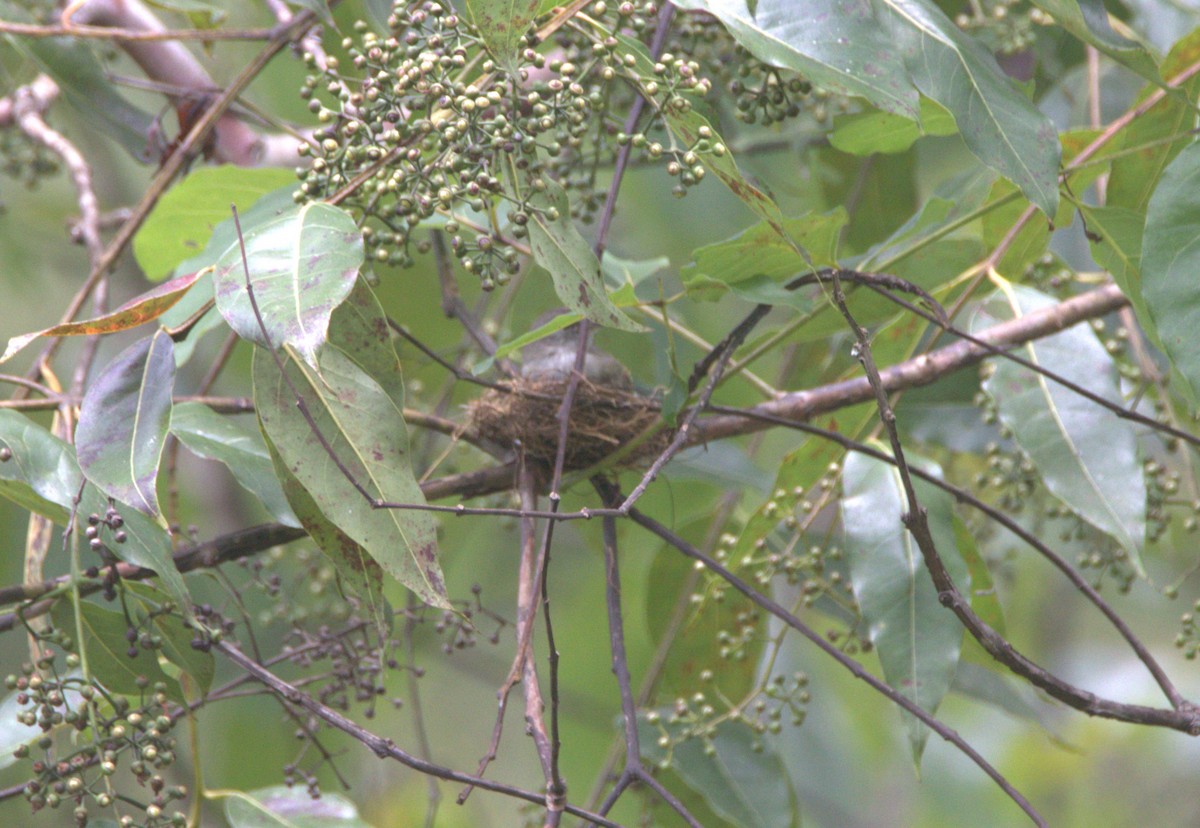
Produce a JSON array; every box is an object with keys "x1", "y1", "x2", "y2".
[{"x1": 638, "y1": 713, "x2": 800, "y2": 828}]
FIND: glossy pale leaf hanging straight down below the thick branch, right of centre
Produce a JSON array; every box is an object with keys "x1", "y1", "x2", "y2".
[{"x1": 841, "y1": 444, "x2": 970, "y2": 764}]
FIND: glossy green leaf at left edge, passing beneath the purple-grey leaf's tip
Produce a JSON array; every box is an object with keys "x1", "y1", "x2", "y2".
[{"x1": 0, "y1": 409, "x2": 191, "y2": 613}]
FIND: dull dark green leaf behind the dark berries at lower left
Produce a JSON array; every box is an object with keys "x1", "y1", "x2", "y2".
[{"x1": 50, "y1": 600, "x2": 185, "y2": 702}]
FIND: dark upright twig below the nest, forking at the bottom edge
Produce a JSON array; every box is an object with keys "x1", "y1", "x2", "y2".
[{"x1": 592, "y1": 499, "x2": 702, "y2": 828}]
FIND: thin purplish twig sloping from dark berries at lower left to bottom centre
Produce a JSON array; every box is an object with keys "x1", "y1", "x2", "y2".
[{"x1": 212, "y1": 641, "x2": 620, "y2": 828}]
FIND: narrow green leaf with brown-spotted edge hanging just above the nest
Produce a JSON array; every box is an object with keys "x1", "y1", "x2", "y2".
[{"x1": 528, "y1": 180, "x2": 646, "y2": 331}]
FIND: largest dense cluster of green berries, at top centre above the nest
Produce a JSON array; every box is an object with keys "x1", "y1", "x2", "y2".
[{"x1": 298, "y1": 0, "x2": 676, "y2": 288}]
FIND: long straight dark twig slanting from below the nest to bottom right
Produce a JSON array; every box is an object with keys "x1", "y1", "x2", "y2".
[{"x1": 629, "y1": 509, "x2": 1046, "y2": 826}]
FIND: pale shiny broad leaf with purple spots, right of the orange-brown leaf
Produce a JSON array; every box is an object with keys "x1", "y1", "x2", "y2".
[{"x1": 212, "y1": 203, "x2": 362, "y2": 366}]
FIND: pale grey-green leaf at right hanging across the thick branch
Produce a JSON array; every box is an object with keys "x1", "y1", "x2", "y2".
[{"x1": 971, "y1": 282, "x2": 1146, "y2": 574}]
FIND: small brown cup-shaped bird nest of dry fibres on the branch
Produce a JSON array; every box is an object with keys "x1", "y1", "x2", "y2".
[{"x1": 467, "y1": 379, "x2": 671, "y2": 470}]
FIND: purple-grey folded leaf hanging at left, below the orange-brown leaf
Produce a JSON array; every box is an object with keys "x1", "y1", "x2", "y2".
[{"x1": 76, "y1": 330, "x2": 175, "y2": 517}]
